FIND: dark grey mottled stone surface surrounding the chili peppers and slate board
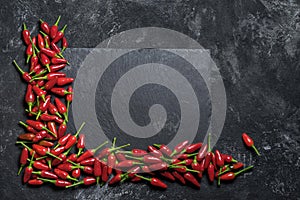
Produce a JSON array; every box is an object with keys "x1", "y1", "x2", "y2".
[{"x1": 0, "y1": 0, "x2": 300, "y2": 199}]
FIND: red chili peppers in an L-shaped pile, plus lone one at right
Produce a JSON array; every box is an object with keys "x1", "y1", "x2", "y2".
[{"x1": 13, "y1": 16, "x2": 260, "y2": 189}]
